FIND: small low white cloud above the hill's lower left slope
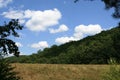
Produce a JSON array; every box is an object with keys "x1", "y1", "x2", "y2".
[{"x1": 31, "y1": 41, "x2": 49, "y2": 49}]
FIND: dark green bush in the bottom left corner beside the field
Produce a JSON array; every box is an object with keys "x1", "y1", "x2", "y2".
[{"x1": 0, "y1": 59, "x2": 20, "y2": 80}]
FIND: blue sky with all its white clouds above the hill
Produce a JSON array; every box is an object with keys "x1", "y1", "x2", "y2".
[{"x1": 0, "y1": 0, "x2": 118, "y2": 55}]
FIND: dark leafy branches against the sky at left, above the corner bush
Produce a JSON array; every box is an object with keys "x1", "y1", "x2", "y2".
[{"x1": 0, "y1": 19, "x2": 23, "y2": 56}]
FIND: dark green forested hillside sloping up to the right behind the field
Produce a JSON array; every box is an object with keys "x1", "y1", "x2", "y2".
[{"x1": 7, "y1": 26, "x2": 120, "y2": 64}]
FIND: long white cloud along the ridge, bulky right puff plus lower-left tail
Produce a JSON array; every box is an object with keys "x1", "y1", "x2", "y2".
[{"x1": 55, "y1": 24, "x2": 103, "y2": 44}]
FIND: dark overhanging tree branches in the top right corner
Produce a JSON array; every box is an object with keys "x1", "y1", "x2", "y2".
[{"x1": 74, "y1": 0, "x2": 120, "y2": 18}]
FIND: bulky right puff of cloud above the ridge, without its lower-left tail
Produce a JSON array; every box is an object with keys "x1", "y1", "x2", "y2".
[{"x1": 73, "y1": 24, "x2": 103, "y2": 39}]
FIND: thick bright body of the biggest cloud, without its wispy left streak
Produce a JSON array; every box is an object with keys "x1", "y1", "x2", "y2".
[{"x1": 26, "y1": 9, "x2": 61, "y2": 31}]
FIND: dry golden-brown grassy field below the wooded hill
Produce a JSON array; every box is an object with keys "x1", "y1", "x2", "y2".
[{"x1": 13, "y1": 63, "x2": 109, "y2": 80}]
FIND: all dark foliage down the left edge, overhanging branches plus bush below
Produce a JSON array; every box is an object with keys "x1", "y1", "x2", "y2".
[{"x1": 0, "y1": 19, "x2": 23, "y2": 80}]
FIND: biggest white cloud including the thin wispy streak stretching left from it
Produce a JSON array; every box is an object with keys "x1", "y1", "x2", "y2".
[{"x1": 2, "y1": 8, "x2": 62, "y2": 31}]
